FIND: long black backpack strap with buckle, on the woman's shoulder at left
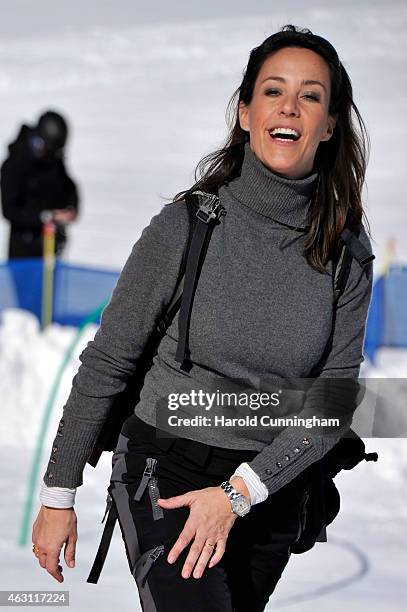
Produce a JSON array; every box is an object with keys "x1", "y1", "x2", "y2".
[{"x1": 175, "y1": 191, "x2": 226, "y2": 370}]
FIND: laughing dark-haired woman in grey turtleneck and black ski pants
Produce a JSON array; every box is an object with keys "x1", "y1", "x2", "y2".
[{"x1": 33, "y1": 26, "x2": 372, "y2": 612}]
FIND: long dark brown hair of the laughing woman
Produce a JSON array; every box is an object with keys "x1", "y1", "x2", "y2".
[{"x1": 173, "y1": 24, "x2": 370, "y2": 272}]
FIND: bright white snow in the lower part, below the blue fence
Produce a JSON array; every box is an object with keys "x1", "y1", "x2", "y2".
[{"x1": 0, "y1": 310, "x2": 407, "y2": 612}]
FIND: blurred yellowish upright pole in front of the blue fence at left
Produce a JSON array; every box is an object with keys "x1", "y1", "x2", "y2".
[{"x1": 41, "y1": 212, "x2": 55, "y2": 329}]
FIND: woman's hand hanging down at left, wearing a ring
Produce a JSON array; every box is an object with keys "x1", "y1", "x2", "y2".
[{"x1": 32, "y1": 506, "x2": 78, "y2": 582}]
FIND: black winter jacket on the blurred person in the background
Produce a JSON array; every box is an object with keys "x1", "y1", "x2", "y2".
[{"x1": 0, "y1": 125, "x2": 79, "y2": 257}]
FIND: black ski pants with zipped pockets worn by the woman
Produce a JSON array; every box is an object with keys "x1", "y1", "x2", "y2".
[{"x1": 98, "y1": 415, "x2": 308, "y2": 612}]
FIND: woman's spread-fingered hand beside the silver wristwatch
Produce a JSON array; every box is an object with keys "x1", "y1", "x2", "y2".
[{"x1": 157, "y1": 486, "x2": 238, "y2": 578}]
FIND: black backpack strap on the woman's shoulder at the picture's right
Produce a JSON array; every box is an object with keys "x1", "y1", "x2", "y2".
[{"x1": 332, "y1": 226, "x2": 375, "y2": 304}]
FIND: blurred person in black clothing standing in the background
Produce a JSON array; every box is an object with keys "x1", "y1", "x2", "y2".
[{"x1": 0, "y1": 110, "x2": 79, "y2": 259}]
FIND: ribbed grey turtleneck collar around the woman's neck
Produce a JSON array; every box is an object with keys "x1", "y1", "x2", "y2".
[{"x1": 226, "y1": 142, "x2": 318, "y2": 228}]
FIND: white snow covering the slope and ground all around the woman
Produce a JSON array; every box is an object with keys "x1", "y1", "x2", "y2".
[{"x1": 0, "y1": 0, "x2": 407, "y2": 612}]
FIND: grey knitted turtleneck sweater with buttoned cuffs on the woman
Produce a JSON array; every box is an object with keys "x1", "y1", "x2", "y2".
[{"x1": 44, "y1": 144, "x2": 373, "y2": 494}]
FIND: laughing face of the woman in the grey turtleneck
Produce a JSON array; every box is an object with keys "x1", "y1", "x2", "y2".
[{"x1": 239, "y1": 47, "x2": 336, "y2": 179}]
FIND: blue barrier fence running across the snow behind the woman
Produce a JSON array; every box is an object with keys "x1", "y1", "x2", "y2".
[{"x1": 0, "y1": 259, "x2": 407, "y2": 363}]
